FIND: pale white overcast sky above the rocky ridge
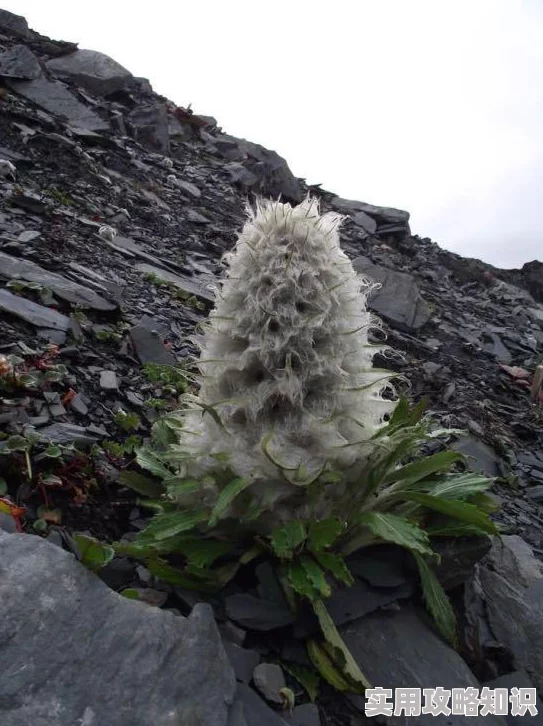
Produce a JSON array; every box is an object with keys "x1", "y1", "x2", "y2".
[{"x1": 4, "y1": 0, "x2": 543, "y2": 267}]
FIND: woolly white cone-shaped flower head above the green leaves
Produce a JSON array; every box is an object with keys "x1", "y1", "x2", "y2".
[{"x1": 172, "y1": 198, "x2": 395, "y2": 521}]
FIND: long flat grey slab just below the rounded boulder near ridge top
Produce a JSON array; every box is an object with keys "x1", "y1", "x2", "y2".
[{"x1": 11, "y1": 78, "x2": 109, "y2": 131}]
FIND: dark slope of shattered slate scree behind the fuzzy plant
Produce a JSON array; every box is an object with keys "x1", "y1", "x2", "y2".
[{"x1": 0, "y1": 10, "x2": 543, "y2": 724}]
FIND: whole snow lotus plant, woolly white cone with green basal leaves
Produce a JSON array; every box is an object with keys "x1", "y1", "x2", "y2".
[{"x1": 116, "y1": 198, "x2": 495, "y2": 690}]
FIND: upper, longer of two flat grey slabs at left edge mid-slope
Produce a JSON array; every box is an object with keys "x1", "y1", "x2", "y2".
[{"x1": 0, "y1": 252, "x2": 117, "y2": 310}]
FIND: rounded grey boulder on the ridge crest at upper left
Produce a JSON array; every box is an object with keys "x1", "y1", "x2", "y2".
[{"x1": 46, "y1": 50, "x2": 132, "y2": 96}]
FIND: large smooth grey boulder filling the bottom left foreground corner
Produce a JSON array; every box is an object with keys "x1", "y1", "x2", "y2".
[{"x1": 0, "y1": 532, "x2": 235, "y2": 726}]
